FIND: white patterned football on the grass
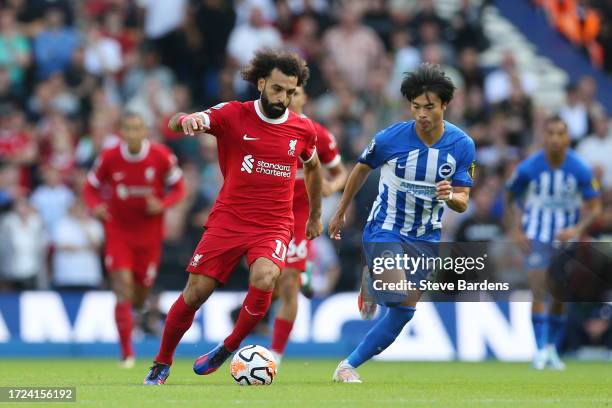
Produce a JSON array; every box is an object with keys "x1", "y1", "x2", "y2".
[{"x1": 230, "y1": 345, "x2": 276, "y2": 385}]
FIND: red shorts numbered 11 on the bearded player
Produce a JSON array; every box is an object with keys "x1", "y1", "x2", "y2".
[{"x1": 187, "y1": 228, "x2": 289, "y2": 284}]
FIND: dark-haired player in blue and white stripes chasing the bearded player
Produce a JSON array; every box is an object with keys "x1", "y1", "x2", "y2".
[{"x1": 329, "y1": 63, "x2": 475, "y2": 382}]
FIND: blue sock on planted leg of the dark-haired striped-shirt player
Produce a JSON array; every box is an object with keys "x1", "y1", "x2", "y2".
[{"x1": 347, "y1": 306, "x2": 416, "y2": 368}]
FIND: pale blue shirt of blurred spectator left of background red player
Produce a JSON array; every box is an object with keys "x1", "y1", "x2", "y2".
[{"x1": 30, "y1": 184, "x2": 74, "y2": 234}]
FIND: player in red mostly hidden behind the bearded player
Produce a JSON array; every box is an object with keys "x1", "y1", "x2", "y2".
[{"x1": 271, "y1": 86, "x2": 347, "y2": 363}]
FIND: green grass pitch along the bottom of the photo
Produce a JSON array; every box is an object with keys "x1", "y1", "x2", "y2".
[{"x1": 0, "y1": 359, "x2": 612, "y2": 408}]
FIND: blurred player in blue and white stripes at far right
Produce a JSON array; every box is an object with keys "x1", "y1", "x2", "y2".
[{"x1": 505, "y1": 116, "x2": 601, "y2": 370}]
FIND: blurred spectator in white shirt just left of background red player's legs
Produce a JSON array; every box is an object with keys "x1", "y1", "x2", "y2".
[{"x1": 51, "y1": 200, "x2": 104, "y2": 290}]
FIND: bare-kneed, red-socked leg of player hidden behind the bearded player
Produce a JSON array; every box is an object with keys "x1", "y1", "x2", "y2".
[{"x1": 271, "y1": 267, "x2": 301, "y2": 364}]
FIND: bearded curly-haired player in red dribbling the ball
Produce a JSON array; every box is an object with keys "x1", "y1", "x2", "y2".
[{"x1": 144, "y1": 50, "x2": 322, "y2": 385}]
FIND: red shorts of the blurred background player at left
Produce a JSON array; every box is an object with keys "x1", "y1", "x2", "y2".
[{"x1": 104, "y1": 228, "x2": 161, "y2": 288}]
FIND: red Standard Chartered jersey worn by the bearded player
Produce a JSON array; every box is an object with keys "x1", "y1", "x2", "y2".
[{"x1": 202, "y1": 101, "x2": 316, "y2": 233}]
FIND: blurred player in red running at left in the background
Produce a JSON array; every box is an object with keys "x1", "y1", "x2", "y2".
[{"x1": 84, "y1": 112, "x2": 185, "y2": 368}]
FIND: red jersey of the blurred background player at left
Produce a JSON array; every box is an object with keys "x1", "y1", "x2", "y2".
[{"x1": 87, "y1": 140, "x2": 182, "y2": 242}]
